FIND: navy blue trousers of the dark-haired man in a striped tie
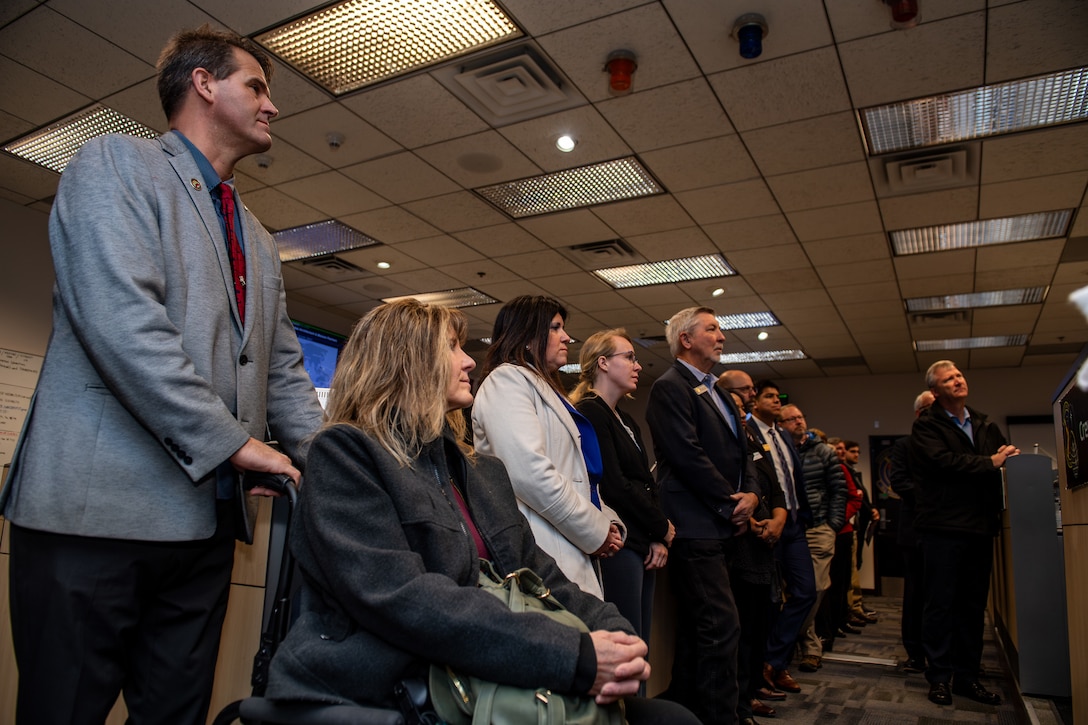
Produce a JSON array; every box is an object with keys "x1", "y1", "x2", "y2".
[{"x1": 766, "y1": 518, "x2": 816, "y2": 669}]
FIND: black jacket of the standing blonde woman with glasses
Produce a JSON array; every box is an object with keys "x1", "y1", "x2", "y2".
[{"x1": 577, "y1": 394, "x2": 669, "y2": 556}]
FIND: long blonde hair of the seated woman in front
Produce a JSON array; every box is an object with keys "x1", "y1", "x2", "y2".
[{"x1": 326, "y1": 299, "x2": 471, "y2": 467}]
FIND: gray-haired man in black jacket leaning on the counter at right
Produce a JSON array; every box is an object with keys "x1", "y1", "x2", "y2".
[{"x1": 910, "y1": 360, "x2": 1019, "y2": 705}]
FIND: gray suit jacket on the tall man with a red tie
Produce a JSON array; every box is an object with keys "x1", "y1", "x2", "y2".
[{"x1": 0, "y1": 133, "x2": 321, "y2": 541}]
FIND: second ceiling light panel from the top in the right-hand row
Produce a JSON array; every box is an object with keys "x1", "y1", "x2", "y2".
[{"x1": 891, "y1": 209, "x2": 1073, "y2": 257}]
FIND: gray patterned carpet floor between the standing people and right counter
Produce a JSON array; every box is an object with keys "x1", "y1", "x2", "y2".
[{"x1": 757, "y1": 597, "x2": 1061, "y2": 725}]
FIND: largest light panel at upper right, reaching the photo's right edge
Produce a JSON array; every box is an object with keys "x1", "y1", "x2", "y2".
[{"x1": 858, "y1": 67, "x2": 1088, "y2": 156}]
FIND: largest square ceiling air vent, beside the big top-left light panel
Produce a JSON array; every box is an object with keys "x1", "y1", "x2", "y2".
[{"x1": 433, "y1": 44, "x2": 585, "y2": 126}]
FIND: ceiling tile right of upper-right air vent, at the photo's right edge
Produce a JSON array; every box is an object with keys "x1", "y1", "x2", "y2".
[{"x1": 981, "y1": 123, "x2": 1088, "y2": 184}]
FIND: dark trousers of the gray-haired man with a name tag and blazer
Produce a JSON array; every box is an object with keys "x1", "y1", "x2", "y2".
[{"x1": 664, "y1": 539, "x2": 740, "y2": 725}]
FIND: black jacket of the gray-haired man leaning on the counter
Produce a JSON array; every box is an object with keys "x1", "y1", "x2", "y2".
[{"x1": 911, "y1": 404, "x2": 1005, "y2": 536}]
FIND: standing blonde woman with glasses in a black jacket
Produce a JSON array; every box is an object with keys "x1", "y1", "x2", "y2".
[{"x1": 571, "y1": 329, "x2": 676, "y2": 642}]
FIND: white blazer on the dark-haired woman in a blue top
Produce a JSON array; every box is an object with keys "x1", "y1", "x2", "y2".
[{"x1": 472, "y1": 364, "x2": 622, "y2": 598}]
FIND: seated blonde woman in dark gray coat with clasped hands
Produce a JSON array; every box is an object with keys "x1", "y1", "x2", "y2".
[{"x1": 267, "y1": 299, "x2": 697, "y2": 725}]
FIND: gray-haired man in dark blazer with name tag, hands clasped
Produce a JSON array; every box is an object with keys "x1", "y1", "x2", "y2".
[{"x1": 646, "y1": 307, "x2": 758, "y2": 725}]
